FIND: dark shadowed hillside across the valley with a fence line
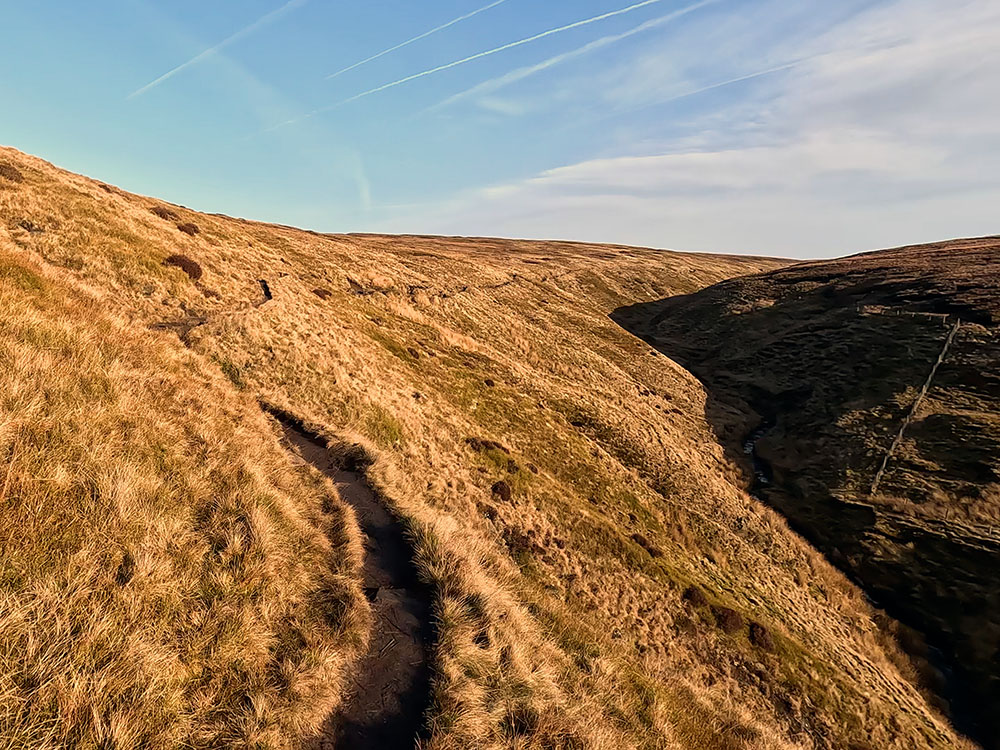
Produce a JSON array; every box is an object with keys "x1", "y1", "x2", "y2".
[{"x1": 614, "y1": 238, "x2": 1000, "y2": 746}]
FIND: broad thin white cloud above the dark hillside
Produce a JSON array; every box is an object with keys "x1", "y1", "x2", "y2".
[{"x1": 388, "y1": 0, "x2": 1000, "y2": 256}]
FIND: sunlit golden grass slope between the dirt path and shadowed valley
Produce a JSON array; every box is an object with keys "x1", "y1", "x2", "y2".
[{"x1": 0, "y1": 150, "x2": 960, "y2": 748}]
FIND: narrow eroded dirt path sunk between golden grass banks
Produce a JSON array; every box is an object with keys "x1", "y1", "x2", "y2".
[{"x1": 275, "y1": 415, "x2": 433, "y2": 750}]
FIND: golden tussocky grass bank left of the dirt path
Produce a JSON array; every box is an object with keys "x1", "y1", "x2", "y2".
[{"x1": 0, "y1": 251, "x2": 367, "y2": 748}]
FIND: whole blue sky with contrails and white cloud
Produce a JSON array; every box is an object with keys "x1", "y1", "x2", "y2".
[{"x1": 0, "y1": 0, "x2": 1000, "y2": 258}]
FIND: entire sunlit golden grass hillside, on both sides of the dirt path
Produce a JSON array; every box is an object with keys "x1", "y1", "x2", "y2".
[{"x1": 0, "y1": 144, "x2": 972, "y2": 750}]
